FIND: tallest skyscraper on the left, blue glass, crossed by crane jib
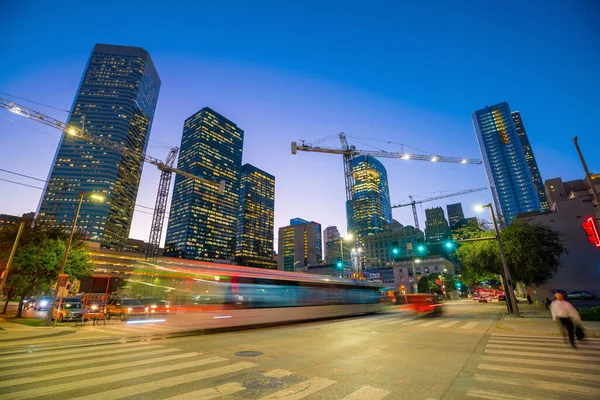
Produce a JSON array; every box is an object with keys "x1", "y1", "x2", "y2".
[{"x1": 38, "y1": 44, "x2": 160, "y2": 249}]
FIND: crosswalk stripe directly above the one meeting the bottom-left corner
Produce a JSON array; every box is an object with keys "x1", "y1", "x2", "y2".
[{"x1": 0, "y1": 353, "x2": 204, "y2": 387}]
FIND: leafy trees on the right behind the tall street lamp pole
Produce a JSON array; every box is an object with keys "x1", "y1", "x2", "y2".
[{"x1": 457, "y1": 220, "x2": 567, "y2": 286}]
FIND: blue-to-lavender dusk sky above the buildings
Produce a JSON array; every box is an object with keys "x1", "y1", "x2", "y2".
[{"x1": 0, "y1": 0, "x2": 600, "y2": 247}]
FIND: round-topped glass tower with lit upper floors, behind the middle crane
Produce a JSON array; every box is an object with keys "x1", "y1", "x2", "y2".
[{"x1": 346, "y1": 156, "x2": 392, "y2": 246}]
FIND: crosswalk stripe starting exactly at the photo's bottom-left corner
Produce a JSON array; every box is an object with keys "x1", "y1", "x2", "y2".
[{"x1": 2, "y1": 357, "x2": 228, "y2": 400}]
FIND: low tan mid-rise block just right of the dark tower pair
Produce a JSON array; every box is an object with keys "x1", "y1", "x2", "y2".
[{"x1": 277, "y1": 222, "x2": 323, "y2": 271}]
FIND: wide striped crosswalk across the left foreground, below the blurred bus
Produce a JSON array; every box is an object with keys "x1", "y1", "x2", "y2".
[{"x1": 0, "y1": 341, "x2": 397, "y2": 400}]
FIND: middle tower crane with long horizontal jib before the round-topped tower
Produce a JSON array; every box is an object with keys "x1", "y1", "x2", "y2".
[{"x1": 292, "y1": 133, "x2": 481, "y2": 234}]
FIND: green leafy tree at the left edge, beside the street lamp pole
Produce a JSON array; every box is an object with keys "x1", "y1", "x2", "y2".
[{"x1": 0, "y1": 223, "x2": 91, "y2": 317}]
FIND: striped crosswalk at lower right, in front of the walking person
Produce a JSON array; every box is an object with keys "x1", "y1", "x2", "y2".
[{"x1": 458, "y1": 334, "x2": 600, "y2": 400}]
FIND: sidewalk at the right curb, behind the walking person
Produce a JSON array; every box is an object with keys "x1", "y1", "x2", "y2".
[{"x1": 496, "y1": 302, "x2": 600, "y2": 338}]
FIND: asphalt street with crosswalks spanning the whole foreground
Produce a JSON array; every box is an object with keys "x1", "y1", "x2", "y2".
[{"x1": 0, "y1": 301, "x2": 600, "y2": 400}]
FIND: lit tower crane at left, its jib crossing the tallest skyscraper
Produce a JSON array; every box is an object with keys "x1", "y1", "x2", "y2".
[{"x1": 0, "y1": 97, "x2": 225, "y2": 262}]
